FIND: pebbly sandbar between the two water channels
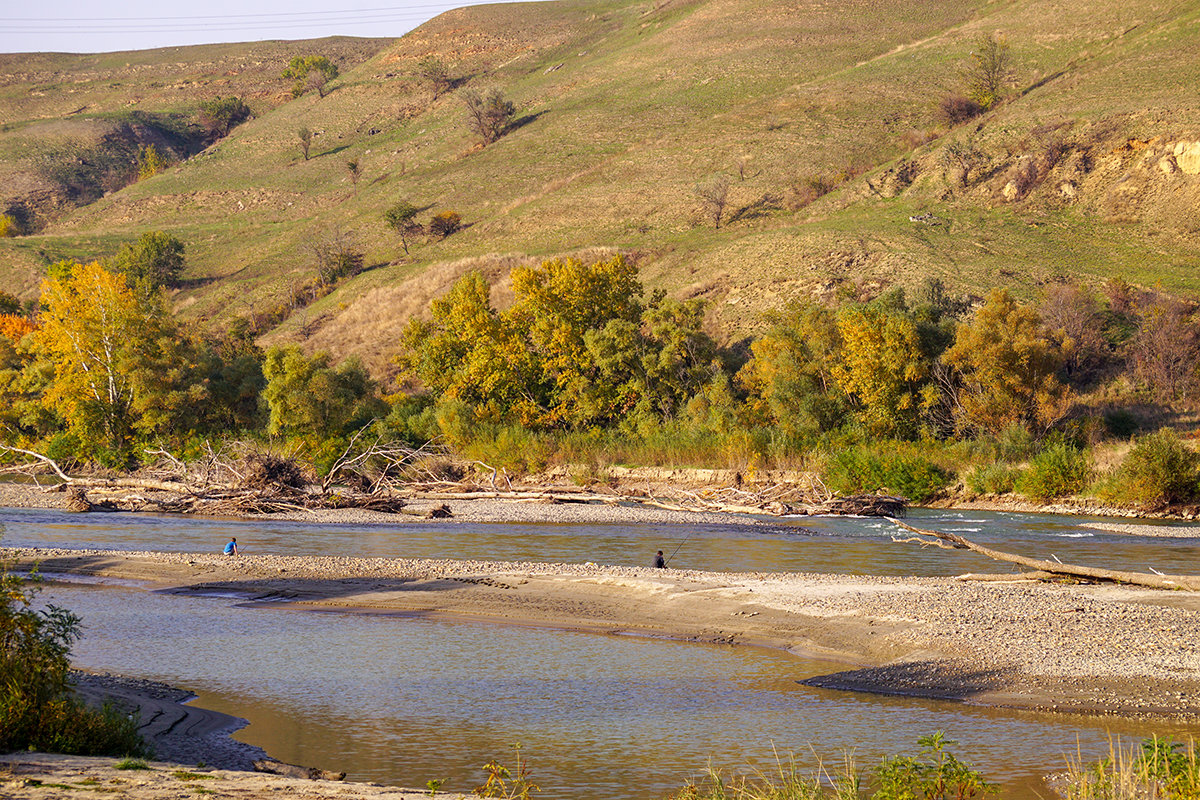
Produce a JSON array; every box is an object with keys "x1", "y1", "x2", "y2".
[{"x1": 9, "y1": 549, "x2": 1200, "y2": 718}]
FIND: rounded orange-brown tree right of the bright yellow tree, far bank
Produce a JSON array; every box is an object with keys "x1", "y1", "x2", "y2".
[{"x1": 942, "y1": 289, "x2": 1073, "y2": 435}]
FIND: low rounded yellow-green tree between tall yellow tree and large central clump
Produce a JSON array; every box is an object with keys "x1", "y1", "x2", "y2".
[{"x1": 263, "y1": 345, "x2": 388, "y2": 438}]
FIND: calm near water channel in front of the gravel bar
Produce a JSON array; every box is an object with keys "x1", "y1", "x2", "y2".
[{"x1": 48, "y1": 585, "x2": 1200, "y2": 800}]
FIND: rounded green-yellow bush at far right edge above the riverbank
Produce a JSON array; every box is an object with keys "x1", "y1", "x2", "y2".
[{"x1": 1102, "y1": 428, "x2": 1200, "y2": 507}]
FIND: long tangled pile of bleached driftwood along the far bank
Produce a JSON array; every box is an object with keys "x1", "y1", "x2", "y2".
[{"x1": 0, "y1": 437, "x2": 907, "y2": 518}]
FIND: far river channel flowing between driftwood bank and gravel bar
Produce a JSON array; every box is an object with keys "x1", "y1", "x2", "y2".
[{"x1": 0, "y1": 509, "x2": 1200, "y2": 576}]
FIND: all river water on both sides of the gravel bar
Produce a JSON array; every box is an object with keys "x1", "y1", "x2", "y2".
[{"x1": 0, "y1": 510, "x2": 1200, "y2": 800}]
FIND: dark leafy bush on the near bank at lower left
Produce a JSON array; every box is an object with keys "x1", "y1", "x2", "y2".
[{"x1": 0, "y1": 571, "x2": 150, "y2": 756}]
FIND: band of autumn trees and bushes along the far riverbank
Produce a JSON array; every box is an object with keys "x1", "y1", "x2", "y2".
[{"x1": 0, "y1": 250, "x2": 1200, "y2": 509}]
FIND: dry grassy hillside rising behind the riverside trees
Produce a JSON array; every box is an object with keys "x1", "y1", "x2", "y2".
[{"x1": 0, "y1": 0, "x2": 1200, "y2": 381}]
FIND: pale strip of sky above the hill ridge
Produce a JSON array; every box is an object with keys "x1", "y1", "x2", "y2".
[{"x1": 0, "y1": 0, "x2": 525, "y2": 53}]
